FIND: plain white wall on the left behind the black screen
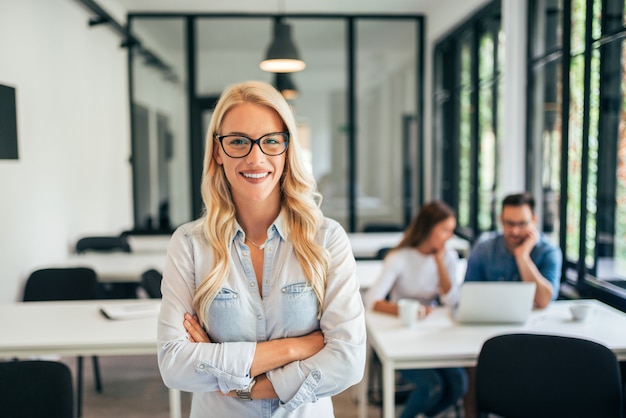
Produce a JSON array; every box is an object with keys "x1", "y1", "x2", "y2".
[{"x1": 0, "y1": 0, "x2": 132, "y2": 302}]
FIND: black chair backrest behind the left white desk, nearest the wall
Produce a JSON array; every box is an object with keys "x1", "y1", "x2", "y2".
[{"x1": 22, "y1": 267, "x2": 98, "y2": 302}]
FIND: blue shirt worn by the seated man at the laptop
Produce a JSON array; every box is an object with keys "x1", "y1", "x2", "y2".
[{"x1": 465, "y1": 232, "x2": 563, "y2": 300}]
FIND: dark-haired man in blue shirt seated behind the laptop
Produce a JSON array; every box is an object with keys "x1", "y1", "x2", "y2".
[{"x1": 465, "y1": 193, "x2": 563, "y2": 308}]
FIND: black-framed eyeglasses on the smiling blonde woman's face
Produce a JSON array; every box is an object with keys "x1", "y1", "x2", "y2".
[{"x1": 215, "y1": 132, "x2": 289, "y2": 158}]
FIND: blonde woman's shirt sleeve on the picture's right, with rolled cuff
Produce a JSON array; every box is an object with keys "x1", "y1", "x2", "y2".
[{"x1": 267, "y1": 221, "x2": 366, "y2": 411}]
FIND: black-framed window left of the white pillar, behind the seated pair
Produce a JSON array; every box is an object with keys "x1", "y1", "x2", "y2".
[{"x1": 434, "y1": 2, "x2": 504, "y2": 239}]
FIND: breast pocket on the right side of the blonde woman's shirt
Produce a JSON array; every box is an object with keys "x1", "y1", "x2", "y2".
[{"x1": 281, "y1": 282, "x2": 319, "y2": 335}]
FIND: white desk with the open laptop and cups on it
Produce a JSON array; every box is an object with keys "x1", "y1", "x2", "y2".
[{"x1": 359, "y1": 301, "x2": 626, "y2": 418}]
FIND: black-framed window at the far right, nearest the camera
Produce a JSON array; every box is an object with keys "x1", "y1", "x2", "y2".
[{"x1": 528, "y1": 0, "x2": 626, "y2": 308}]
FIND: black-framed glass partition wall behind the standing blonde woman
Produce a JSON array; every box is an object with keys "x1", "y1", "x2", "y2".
[{"x1": 128, "y1": 14, "x2": 424, "y2": 231}]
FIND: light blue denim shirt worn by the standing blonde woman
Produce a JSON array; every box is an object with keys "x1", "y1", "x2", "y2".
[{"x1": 158, "y1": 214, "x2": 366, "y2": 418}]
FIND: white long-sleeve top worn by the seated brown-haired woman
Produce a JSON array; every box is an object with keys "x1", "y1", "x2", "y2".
[{"x1": 365, "y1": 247, "x2": 459, "y2": 309}]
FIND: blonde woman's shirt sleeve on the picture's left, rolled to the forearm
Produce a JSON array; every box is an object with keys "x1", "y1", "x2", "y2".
[{"x1": 157, "y1": 226, "x2": 256, "y2": 393}]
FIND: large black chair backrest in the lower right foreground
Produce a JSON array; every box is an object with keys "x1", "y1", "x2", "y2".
[{"x1": 476, "y1": 334, "x2": 623, "y2": 418}]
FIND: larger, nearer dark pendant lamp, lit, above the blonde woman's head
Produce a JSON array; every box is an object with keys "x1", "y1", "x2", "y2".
[{"x1": 259, "y1": 18, "x2": 306, "y2": 73}]
